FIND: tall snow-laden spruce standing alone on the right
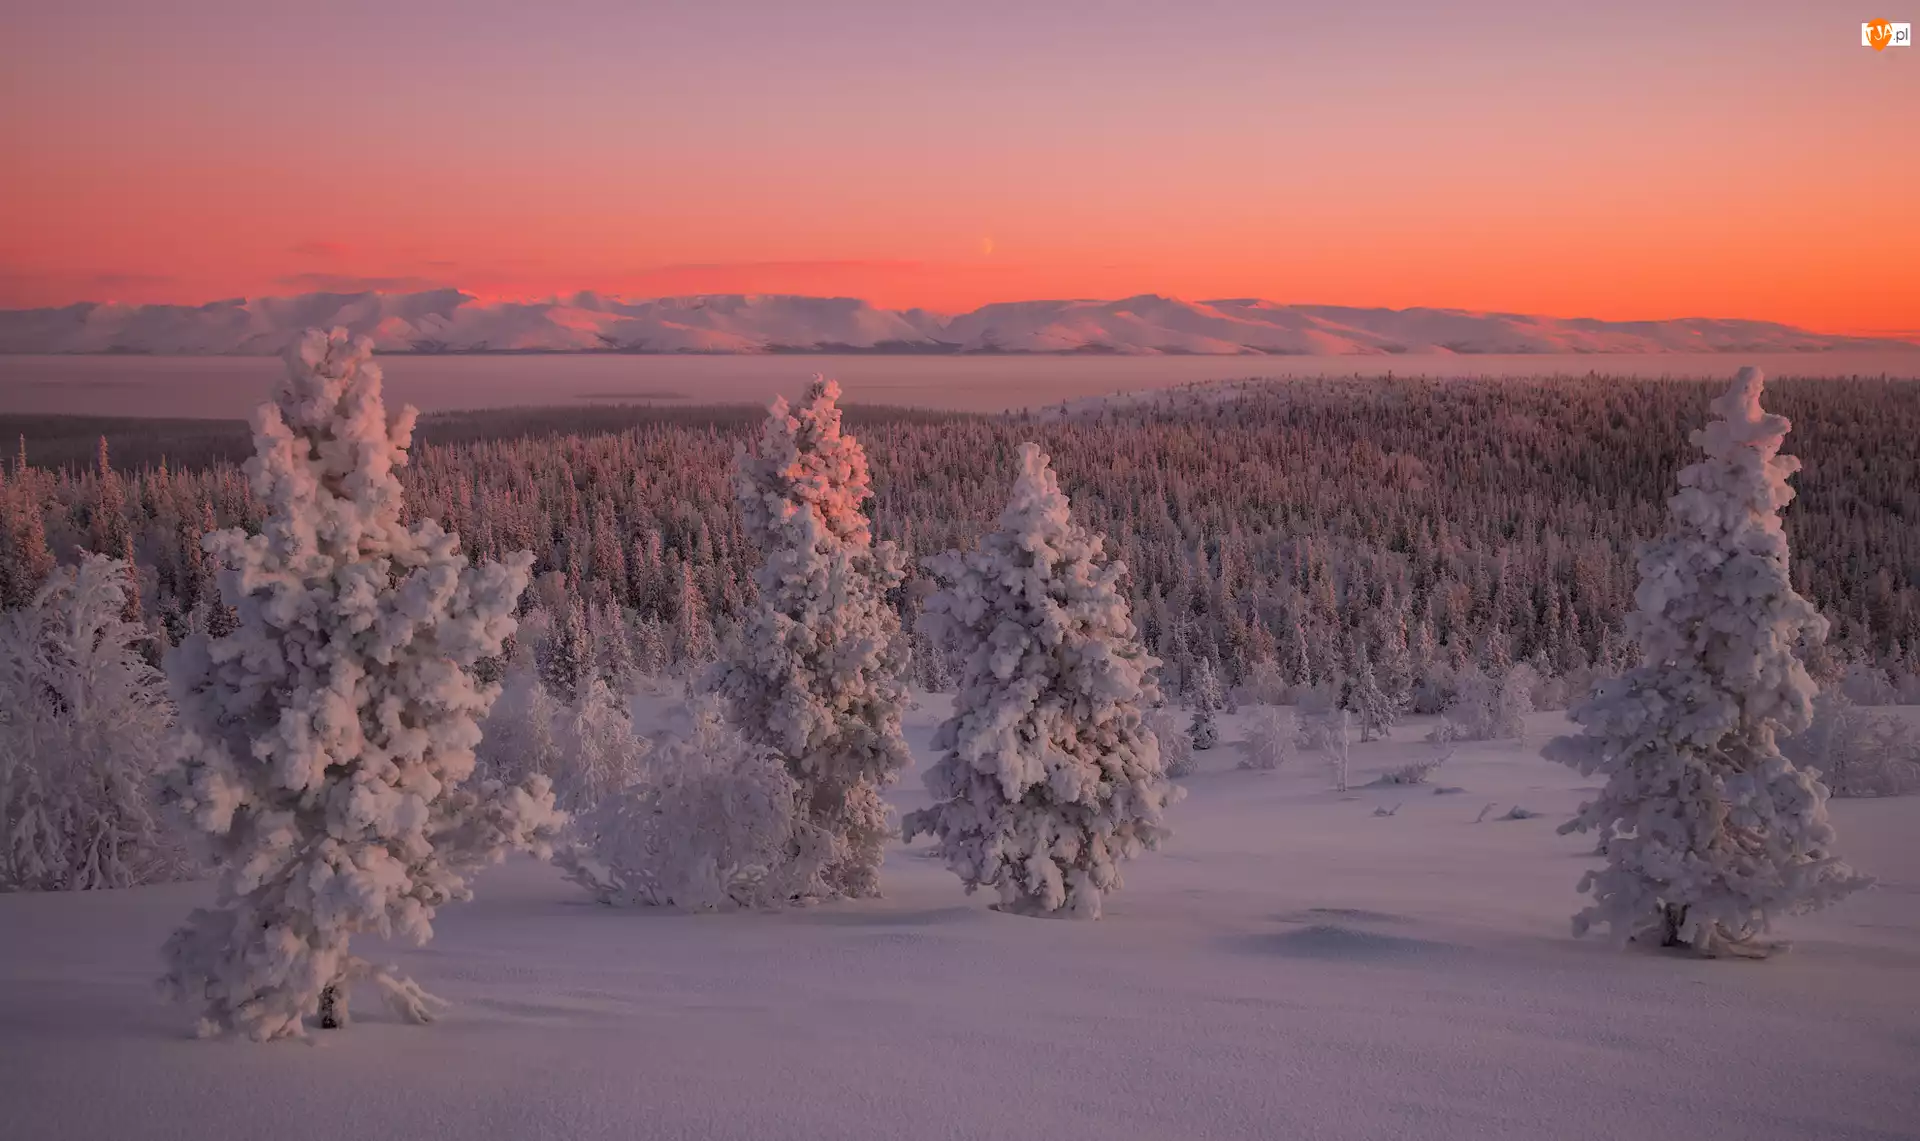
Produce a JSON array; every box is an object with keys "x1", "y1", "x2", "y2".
[{"x1": 1548, "y1": 369, "x2": 1868, "y2": 955}]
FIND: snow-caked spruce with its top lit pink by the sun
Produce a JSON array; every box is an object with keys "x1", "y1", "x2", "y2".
[{"x1": 710, "y1": 376, "x2": 912, "y2": 897}]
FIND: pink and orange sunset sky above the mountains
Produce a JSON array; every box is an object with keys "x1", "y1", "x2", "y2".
[{"x1": 0, "y1": 0, "x2": 1920, "y2": 332}]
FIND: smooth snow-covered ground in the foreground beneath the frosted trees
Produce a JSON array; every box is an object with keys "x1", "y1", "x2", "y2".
[{"x1": 0, "y1": 699, "x2": 1920, "y2": 1141}]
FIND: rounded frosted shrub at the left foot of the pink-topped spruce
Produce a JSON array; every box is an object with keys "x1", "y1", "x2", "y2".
[{"x1": 557, "y1": 699, "x2": 833, "y2": 910}]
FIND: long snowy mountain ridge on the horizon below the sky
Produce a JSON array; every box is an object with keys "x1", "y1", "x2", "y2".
[{"x1": 0, "y1": 290, "x2": 1920, "y2": 355}]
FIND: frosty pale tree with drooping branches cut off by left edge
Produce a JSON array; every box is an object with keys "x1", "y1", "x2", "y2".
[{"x1": 0, "y1": 555, "x2": 188, "y2": 891}]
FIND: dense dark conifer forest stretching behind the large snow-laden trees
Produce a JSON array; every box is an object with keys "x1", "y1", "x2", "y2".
[{"x1": 0, "y1": 378, "x2": 1920, "y2": 692}]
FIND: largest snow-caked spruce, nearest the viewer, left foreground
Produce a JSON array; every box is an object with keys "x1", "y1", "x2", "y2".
[{"x1": 163, "y1": 328, "x2": 563, "y2": 1039}]
